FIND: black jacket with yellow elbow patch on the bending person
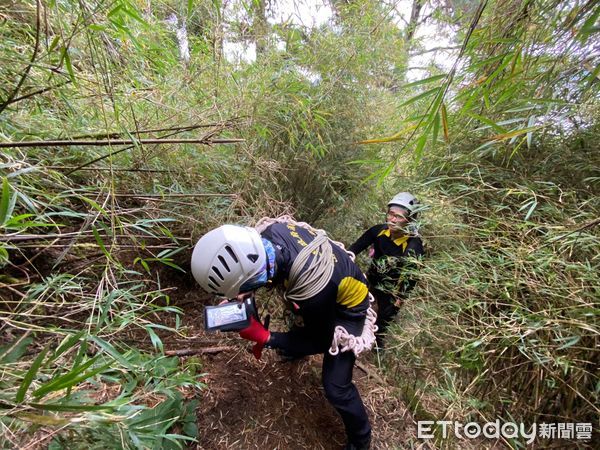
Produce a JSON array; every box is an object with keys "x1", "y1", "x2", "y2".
[{"x1": 261, "y1": 223, "x2": 369, "y2": 338}]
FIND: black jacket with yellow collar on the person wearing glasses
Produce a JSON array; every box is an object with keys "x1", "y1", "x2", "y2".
[{"x1": 349, "y1": 224, "x2": 425, "y2": 295}]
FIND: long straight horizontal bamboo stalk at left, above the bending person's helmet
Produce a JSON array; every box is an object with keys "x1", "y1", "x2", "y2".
[{"x1": 0, "y1": 138, "x2": 246, "y2": 148}]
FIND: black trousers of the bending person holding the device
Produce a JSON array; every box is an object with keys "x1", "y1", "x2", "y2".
[{"x1": 268, "y1": 328, "x2": 371, "y2": 447}]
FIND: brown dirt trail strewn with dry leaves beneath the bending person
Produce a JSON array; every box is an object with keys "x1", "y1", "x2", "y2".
[{"x1": 165, "y1": 276, "x2": 427, "y2": 450}]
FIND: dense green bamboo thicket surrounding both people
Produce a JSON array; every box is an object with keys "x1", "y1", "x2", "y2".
[{"x1": 0, "y1": 0, "x2": 600, "y2": 449}]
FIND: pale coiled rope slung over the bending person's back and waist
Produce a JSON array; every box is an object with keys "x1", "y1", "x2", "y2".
[{"x1": 254, "y1": 215, "x2": 377, "y2": 356}]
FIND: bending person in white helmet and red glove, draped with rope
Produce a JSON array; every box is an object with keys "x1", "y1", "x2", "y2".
[{"x1": 192, "y1": 216, "x2": 376, "y2": 449}]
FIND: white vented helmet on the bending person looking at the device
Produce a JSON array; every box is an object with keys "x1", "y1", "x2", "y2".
[{"x1": 192, "y1": 225, "x2": 266, "y2": 298}]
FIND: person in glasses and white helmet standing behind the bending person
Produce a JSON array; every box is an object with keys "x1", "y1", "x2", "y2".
[{"x1": 349, "y1": 192, "x2": 425, "y2": 348}]
